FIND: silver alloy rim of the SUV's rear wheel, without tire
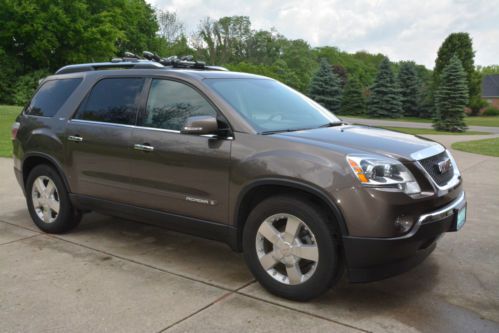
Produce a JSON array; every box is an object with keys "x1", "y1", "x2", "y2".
[{"x1": 31, "y1": 176, "x2": 61, "y2": 223}]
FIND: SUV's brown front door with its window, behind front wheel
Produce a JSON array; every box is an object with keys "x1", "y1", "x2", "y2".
[{"x1": 131, "y1": 79, "x2": 231, "y2": 223}]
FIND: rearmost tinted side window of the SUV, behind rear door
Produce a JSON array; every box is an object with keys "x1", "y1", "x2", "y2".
[{"x1": 26, "y1": 79, "x2": 81, "y2": 117}]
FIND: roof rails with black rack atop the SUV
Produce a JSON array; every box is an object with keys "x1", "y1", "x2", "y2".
[{"x1": 55, "y1": 51, "x2": 227, "y2": 74}]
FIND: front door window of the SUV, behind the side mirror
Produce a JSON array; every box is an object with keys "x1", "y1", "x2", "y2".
[{"x1": 140, "y1": 80, "x2": 217, "y2": 131}]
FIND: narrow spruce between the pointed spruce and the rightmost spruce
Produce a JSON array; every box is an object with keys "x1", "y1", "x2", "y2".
[{"x1": 398, "y1": 62, "x2": 421, "y2": 117}]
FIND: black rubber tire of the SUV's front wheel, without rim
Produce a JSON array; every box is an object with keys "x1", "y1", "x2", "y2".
[{"x1": 243, "y1": 195, "x2": 343, "y2": 301}]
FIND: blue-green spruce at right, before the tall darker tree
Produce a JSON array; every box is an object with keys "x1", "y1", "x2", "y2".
[{"x1": 433, "y1": 55, "x2": 469, "y2": 132}]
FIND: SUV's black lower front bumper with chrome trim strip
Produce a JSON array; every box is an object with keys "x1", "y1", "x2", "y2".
[{"x1": 343, "y1": 192, "x2": 466, "y2": 282}]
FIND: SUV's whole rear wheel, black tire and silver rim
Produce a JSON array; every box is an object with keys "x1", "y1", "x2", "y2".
[{"x1": 26, "y1": 164, "x2": 81, "y2": 233}]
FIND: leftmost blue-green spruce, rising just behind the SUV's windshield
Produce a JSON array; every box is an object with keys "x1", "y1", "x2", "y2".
[{"x1": 310, "y1": 59, "x2": 341, "y2": 113}]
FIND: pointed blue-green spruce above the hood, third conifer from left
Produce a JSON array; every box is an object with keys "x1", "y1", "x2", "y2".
[{"x1": 367, "y1": 58, "x2": 402, "y2": 118}]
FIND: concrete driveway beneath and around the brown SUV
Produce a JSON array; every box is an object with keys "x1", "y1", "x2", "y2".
[{"x1": 0, "y1": 136, "x2": 499, "y2": 333}]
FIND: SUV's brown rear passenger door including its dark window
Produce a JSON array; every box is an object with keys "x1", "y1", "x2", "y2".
[{"x1": 66, "y1": 77, "x2": 145, "y2": 203}]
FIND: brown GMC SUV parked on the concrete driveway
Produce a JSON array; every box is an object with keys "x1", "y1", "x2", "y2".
[{"x1": 13, "y1": 61, "x2": 466, "y2": 300}]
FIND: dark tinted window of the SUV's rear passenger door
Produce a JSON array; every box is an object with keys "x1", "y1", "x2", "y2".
[{"x1": 75, "y1": 78, "x2": 144, "y2": 125}]
